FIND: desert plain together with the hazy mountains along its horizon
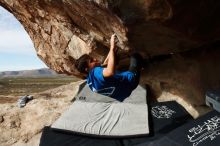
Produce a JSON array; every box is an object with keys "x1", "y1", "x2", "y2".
[{"x1": 0, "y1": 69, "x2": 79, "y2": 103}]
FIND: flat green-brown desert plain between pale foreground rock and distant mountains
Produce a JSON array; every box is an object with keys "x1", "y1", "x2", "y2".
[{"x1": 0, "y1": 76, "x2": 79, "y2": 100}]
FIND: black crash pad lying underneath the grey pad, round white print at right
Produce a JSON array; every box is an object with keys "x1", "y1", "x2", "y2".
[{"x1": 40, "y1": 101, "x2": 192, "y2": 146}]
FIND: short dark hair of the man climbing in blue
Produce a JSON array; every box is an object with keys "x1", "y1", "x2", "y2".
[{"x1": 75, "y1": 54, "x2": 91, "y2": 73}]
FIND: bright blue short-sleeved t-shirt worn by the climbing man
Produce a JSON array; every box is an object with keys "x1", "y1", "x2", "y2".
[{"x1": 87, "y1": 66, "x2": 138, "y2": 101}]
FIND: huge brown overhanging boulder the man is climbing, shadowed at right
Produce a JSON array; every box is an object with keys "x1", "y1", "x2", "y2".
[{"x1": 0, "y1": 0, "x2": 220, "y2": 105}]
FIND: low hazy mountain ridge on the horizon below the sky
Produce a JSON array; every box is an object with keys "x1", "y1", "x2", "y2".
[{"x1": 0, "y1": 68, "x2": 61, "y2": 78}]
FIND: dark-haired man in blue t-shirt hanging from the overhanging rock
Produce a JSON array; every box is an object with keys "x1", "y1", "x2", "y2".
[{"x1": 75, "y1": 34, "x2": 142, "y2": 101}]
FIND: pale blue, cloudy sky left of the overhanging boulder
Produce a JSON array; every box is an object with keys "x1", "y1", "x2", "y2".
[{"x1": 0, "y1": 6, "x2": 46, "y2": 72}]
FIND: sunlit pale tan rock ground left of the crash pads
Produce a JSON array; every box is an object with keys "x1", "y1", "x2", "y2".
[{"x1": 0, "y1": 81, "x2": 82, "y2": 146}]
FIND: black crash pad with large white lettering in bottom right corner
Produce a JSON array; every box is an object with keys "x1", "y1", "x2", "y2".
[{"x1": 135, "y1": 111, "x2": 220, "y2": 146}]
